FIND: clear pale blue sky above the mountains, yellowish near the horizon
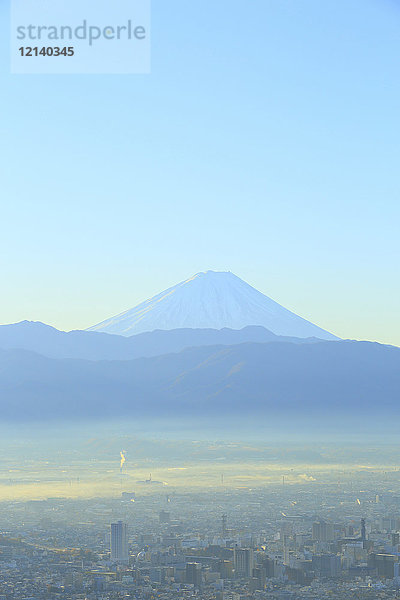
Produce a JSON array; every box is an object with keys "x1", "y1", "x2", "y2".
[{"x1": 0, "y1": 0, "x2": 400, "y2": 345}]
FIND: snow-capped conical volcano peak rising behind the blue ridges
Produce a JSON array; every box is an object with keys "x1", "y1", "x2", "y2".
[{"x1": 87, "y1": 271, "x2": 338, "y2": 340}]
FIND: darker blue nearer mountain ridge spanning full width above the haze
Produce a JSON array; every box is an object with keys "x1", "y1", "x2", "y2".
[{"x1": 0, "y1": 341, "x2": 400, "y2": 426}]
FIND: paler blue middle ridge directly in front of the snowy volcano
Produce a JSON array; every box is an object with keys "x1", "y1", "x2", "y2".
[{"x1": 0, "y1": 321, "x2": 317, "y2": 360}]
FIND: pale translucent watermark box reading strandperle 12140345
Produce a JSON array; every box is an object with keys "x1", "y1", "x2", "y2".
[{"x1": 11, "y1": 0, "x2": 151, "y2": 74}]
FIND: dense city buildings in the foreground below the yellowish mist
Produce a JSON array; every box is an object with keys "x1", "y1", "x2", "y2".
[{"x1": 0, "y1": 486, "x2": 400, "y2": 600}]
